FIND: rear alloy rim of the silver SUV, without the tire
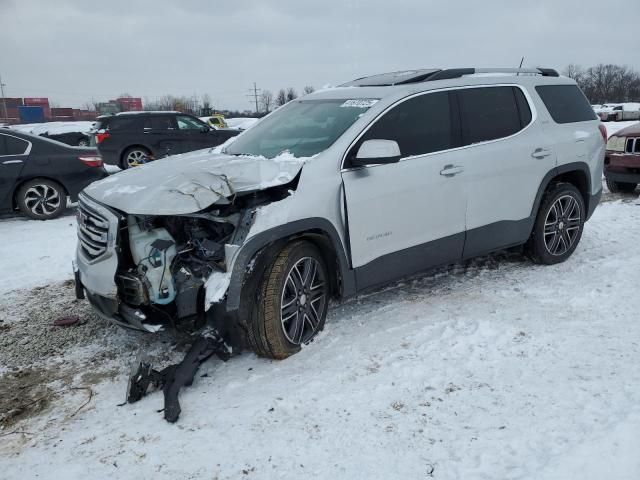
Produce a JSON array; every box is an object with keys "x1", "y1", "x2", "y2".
[{"x1": 544, "y1": 195, "x2": 582, "y2": 256}]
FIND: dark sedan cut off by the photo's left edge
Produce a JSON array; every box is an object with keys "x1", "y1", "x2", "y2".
[{"x1": 0, "y1": 130, "x2": 108, "y2": 220}]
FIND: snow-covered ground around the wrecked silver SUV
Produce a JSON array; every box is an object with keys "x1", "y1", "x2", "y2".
[{"x1": 0, "y1": 189, "x2": 640, "y2": 480}]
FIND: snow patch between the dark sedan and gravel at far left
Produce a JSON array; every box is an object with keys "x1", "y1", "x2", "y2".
[{"x1": 0, "y1": 210, "x2": 77, "y2": 295}]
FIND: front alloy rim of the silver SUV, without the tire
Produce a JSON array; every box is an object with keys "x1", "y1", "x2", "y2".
[{"x1": 280, "y1": 257, "x2": 327, "y2": 345}]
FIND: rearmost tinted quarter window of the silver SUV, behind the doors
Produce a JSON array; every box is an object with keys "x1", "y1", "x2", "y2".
[{"x1": 536, "y1": 85, "x2": 598, "y2": 123}]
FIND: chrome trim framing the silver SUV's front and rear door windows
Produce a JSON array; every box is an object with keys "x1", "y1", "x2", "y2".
[{"x1": 340, "y1": 83, "x2": 538, "y2": 173}]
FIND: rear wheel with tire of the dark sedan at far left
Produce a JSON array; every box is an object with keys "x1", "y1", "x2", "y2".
[{"x1": 16, "y1": 178, "x2": 67, "y2": 220}]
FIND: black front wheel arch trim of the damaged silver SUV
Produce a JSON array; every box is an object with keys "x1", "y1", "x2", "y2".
[{"x1": 226, "y1": 217, "x2": 356, "y2": 315}]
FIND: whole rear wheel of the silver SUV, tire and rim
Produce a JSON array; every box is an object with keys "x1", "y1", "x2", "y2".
[{"x1": 525, "y1": 182, "x2": 586, "y2": 265}]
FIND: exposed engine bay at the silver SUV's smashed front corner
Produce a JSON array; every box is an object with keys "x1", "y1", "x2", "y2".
[{"x1": 116, "y1": 182, "x2": 288, "y2": 331}]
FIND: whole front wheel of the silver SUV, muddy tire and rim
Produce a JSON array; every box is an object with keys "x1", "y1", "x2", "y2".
[{"x1": 247, "y1": 241, "x2": 330, "y2": 359}]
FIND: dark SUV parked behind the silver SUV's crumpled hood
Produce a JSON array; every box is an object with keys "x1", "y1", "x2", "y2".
[{"x1": 93, "y1": 112, "x2": 239, "y2": 168}]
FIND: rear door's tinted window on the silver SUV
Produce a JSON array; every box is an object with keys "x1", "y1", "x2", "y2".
[{"x1": 458, "y1": 87, "x2": 531, "y2": 145}]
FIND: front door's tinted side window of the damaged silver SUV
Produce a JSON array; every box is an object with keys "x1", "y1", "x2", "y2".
[{"x1": 358, "y1": 92, "x2": 458, "y2": 157}]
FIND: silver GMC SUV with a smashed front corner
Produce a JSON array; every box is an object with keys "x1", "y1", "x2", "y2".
[{"x1": 76, "y1": 69, "x2": 606, "y2": 358}]
